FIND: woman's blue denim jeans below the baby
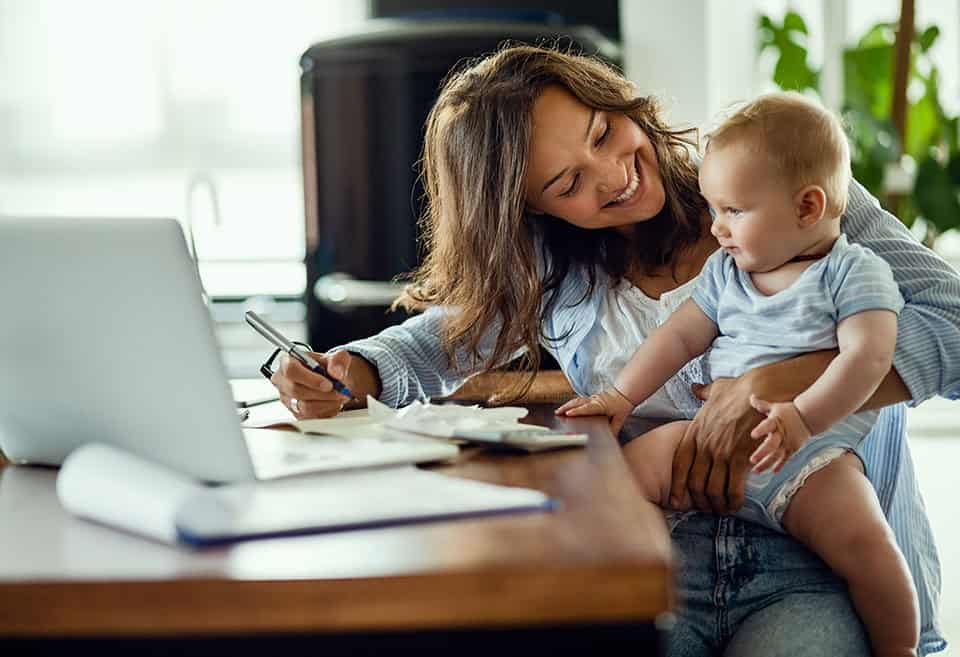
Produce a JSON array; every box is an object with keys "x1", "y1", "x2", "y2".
[{"x1": 667, "y1": 512, "x2": 870, "y2": 657}]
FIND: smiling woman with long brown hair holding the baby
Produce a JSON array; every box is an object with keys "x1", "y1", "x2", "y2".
[{"x1": 273, "y1": 46, "x2": 960, "y2": 656}]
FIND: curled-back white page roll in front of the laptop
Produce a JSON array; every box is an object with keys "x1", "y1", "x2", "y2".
[{"x1": 57, "y1": 443, "x2": 204, "y2": 543}]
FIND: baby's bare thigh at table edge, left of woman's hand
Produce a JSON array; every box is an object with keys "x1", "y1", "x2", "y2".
[{"x1": 623, "y1": 420, "x2": 690, "y2": 508}]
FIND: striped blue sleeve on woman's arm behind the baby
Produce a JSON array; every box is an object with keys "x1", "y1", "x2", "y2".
[{"x1": 843, "y1": 181, "x2": 960, "y2": 405}]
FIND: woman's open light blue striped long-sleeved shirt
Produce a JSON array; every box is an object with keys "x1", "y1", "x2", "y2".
[{"x1": 341, "y1": 181, "x2": 960, "y2": 654}]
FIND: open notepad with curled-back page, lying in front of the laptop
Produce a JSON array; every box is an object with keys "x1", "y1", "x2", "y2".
[{"x1": 57, "y1": 443, "x2": 555, "y2": 546}]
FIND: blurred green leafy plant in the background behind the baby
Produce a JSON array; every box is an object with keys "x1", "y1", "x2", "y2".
[{"x1": 758, "y1": 7, "x2": 960, "y2": 254}]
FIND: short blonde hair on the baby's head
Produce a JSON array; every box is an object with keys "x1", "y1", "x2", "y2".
[{"x1": 706, "y1": 91, "x2": 850, "y2": 217}]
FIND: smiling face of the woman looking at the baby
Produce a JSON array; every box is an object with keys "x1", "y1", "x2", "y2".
[{"x1": 526, "y1": 85, "x2": 666, "y2": 228}]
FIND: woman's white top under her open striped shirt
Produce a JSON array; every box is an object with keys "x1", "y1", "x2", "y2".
[{"x1": 581, "y1": 277, "x2": 699, "y2": 420}]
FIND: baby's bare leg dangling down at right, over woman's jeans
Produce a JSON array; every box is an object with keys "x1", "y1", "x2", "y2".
[{"x1": 783, "y1": 454, "x2": 919, "y2": 657}]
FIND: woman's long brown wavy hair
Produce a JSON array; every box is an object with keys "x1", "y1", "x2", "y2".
[{"x1": 395, "y1": 45, "x2": 706, "y2": 399}]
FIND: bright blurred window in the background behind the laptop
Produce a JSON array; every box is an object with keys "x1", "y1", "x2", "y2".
[{"x1": 0, "y1": 0, "x2": 367, "y2": 297}]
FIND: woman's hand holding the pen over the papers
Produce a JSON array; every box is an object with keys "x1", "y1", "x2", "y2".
[{"x1": 270, "y1": 351, "x2": 380, "y2": 420}]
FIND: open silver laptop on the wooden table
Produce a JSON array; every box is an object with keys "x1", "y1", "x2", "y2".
[{"x1": 0, "y1": 217, "x2": 457, "y2": 482}]
